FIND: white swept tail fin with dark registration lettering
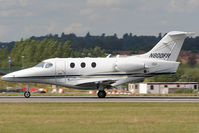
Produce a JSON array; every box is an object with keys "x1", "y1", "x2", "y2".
[{"x1": 140, "y1": 31, "x2": 194, "y2": 61}]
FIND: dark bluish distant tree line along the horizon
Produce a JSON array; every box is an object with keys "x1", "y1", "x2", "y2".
[{"x1": 0, "y1": 32, "x2": 199, "y2": 53}]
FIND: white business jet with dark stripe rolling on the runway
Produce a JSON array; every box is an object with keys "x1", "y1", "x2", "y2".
[{"x1": 2, "y1": 31, "x2": 193, "y2": 98}]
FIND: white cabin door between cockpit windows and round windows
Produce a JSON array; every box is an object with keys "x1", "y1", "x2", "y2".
[{"x1": 55, "y1": 61, "x2": 66, "y2": 83}]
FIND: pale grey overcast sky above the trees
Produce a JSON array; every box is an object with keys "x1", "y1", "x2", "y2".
[{"x1": 0, "y1": 0, "x2": 199, "y2": 42}]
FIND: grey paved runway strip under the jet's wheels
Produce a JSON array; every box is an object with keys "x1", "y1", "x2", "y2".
[{"x1": 0, "y1": 96, "x2": 199, "y2": 103}]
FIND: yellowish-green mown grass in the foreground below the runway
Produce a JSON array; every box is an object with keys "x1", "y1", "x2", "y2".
[{"x1": 0, "y1": 103, "x2": 199, "y2": 133}]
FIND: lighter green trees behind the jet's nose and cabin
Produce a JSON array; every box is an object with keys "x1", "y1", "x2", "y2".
[{"x1": 0, "y1": 39, "x2": 105, "y2": 68}]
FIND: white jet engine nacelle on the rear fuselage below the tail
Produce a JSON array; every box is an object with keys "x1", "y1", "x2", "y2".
[{"x1": 115, "y1": 60, "x2": 145, "y2": 72}]
